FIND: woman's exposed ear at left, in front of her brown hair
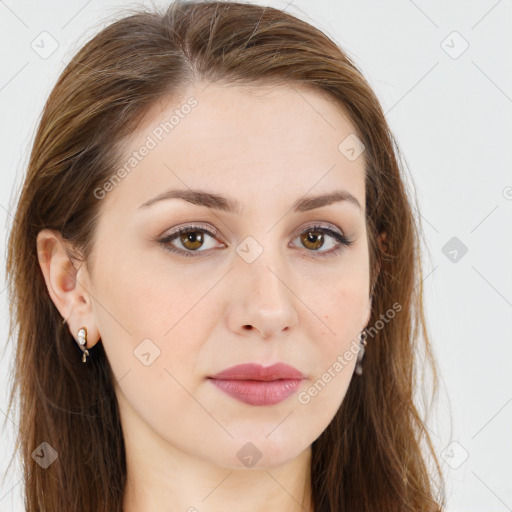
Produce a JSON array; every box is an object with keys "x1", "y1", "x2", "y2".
[{"x1": 37, "y1": 229, "x2": 100, "y2": 348}]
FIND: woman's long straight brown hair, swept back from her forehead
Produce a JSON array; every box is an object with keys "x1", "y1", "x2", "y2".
[{"x1": 7, "y1": 1, "x2": 444, "y2": 512}]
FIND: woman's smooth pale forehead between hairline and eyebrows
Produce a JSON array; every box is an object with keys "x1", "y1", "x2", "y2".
[{"x1": 105, "y1": 83, "x2": 365, "y2": 213}]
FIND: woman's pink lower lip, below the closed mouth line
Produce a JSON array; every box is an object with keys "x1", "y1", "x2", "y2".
[{"x1": 210, "y1": 379, "x2": 302, "y2": 405}]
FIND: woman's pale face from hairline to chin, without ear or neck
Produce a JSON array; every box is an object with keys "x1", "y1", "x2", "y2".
[{"x1": 88, "y1": 83, "x2": 371, "y2": 468}]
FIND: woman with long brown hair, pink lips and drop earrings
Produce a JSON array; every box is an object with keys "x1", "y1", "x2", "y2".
[{"x1": 7, "y1": 2, "x2": 444, "y2": 512}]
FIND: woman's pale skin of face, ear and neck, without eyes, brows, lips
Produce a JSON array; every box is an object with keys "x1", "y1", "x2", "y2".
[{"x1": 37, "y1": 83, "x2": 371, "y2": 512}]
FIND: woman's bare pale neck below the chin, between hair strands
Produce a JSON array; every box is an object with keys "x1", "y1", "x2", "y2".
[{"x1": 123, "y1": 448, "x2": 314, "y2": 512}]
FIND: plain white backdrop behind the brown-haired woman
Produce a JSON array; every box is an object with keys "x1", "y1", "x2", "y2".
[{"x1": 0, "y1": 0, "x2": 512, "y2": 512}]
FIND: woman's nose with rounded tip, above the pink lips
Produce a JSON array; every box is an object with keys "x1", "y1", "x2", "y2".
[{"x1": 228, "y1": 253, "x2": 298, "y2": 339}]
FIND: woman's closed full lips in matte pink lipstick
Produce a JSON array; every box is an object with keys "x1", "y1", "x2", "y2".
[{"x1": 208, "y1": 363, "x2": 306, "y2": 405}]
